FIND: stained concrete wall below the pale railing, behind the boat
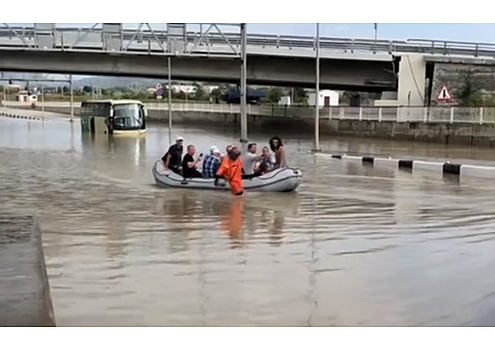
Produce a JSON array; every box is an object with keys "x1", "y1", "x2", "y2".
[{"x1": 8, "y1": 107, "x2": 495, "y2": 147}]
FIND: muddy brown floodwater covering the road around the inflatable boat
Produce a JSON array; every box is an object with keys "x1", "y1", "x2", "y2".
[{"x1": 0, "y1": 118, "x2": 495, "y2": 326}]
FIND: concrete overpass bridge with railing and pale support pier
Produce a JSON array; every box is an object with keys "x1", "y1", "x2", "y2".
[{"x1": 0, "y1": 23, "x2": 495, "y2": 105}]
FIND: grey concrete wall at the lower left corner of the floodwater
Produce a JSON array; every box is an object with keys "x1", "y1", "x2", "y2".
[{"x1": 0, "y1": 214, "x2": 55, "y2": 327}]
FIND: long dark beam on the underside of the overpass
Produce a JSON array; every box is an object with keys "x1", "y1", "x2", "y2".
[{"x1": 0, "y1": 50, "x2": 397, "y2": 92}]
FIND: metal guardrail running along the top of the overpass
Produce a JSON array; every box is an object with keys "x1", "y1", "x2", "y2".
[{"x1": 0, "y1": 27, "x2": 495, "y2": 57}]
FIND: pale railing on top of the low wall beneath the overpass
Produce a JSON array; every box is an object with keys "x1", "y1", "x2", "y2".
[{"x1": 2, "y1": 101, "x2": 495, "y2": 125}]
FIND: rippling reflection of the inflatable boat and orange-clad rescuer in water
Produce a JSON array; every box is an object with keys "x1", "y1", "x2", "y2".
[{"x1": 156, "y1": 190, "x2": 301, "y2": 251}]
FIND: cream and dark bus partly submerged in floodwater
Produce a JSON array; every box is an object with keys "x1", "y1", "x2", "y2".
[{"x1": 81, "y1": 100, "x2": 147, "y2": 135}]
